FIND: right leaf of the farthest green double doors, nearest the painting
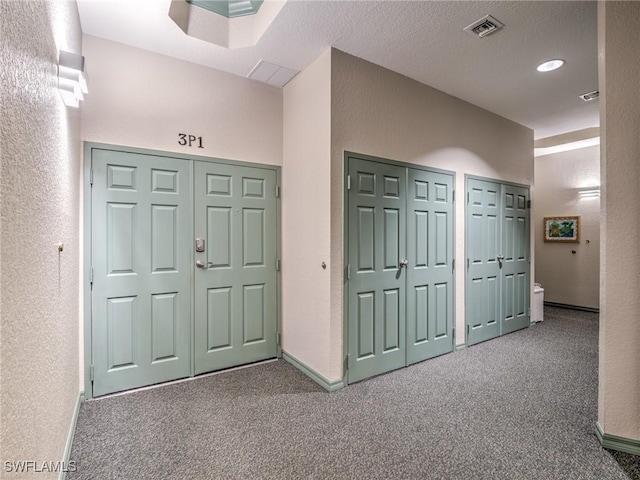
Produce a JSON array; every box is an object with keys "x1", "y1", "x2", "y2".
[{"x1": 502, "y1": 185, "x2": 530, "y2": 334}]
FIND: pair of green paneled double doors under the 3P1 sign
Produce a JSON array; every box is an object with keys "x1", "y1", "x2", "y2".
[{"x1": 90, "y1": 148, "x2": 277, "y2": 396}]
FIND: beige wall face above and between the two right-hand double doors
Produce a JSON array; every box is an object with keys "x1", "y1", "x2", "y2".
[{"x1": 329, "y1": 50, "x2": 535, "y2": 378}]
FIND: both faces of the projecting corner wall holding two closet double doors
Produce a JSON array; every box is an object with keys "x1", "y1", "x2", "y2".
[{"x1": 283, "y1": 49, "x2": 535, "y2": 383}]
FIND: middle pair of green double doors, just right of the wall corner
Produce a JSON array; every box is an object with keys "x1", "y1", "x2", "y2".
[{"x1": 347, "y1": 155, "x2": 454, "y2": 382}]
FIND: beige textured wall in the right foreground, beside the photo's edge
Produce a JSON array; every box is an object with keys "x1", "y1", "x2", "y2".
[{"x1": 598, "y1": 1, "x2": 640, "y2": 441}]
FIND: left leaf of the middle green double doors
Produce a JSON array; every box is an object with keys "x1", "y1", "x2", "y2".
[{"x1": 348, "y1": 158, "x2": 407, "y2": 382}]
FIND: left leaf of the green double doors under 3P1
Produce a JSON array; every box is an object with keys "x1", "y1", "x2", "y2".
[{"x1": 91, "y1": 149, "x2": 191, "y2": 396}]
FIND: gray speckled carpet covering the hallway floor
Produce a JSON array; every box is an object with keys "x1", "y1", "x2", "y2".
[{"x1": 67, "y1": 307, "x2": 640, "y2": 480}]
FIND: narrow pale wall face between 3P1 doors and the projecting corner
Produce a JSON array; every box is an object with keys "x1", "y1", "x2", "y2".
[{"x1": 282, "y1": 50, "x2": 335, "y2": 379}]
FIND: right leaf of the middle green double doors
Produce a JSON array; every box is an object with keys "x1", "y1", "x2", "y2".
[{"x1": 407, "y1": 168, "x2": 454, "y2": 364}]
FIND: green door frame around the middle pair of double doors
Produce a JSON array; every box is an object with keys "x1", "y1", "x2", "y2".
[{"x1": 342, "y1": 150, "x2": 456, "y2": 386}]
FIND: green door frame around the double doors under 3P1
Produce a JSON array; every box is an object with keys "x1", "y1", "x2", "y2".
[{"x1": 80, "y1": 141, "x2": 282, "y2": 400}]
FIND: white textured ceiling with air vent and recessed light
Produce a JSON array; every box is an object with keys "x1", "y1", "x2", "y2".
[{"x1": 78, "y1": 0, "x2": 599, "y2": 138}]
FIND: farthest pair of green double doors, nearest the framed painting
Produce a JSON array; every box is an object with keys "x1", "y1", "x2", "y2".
[{"x1": 466, "y1": 178, "x2": 530, "y2": 345}]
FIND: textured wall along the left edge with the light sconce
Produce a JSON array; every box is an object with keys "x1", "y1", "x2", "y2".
[{"x1": 0, "y1": 0, "x2": 81, "y2": 479}]
